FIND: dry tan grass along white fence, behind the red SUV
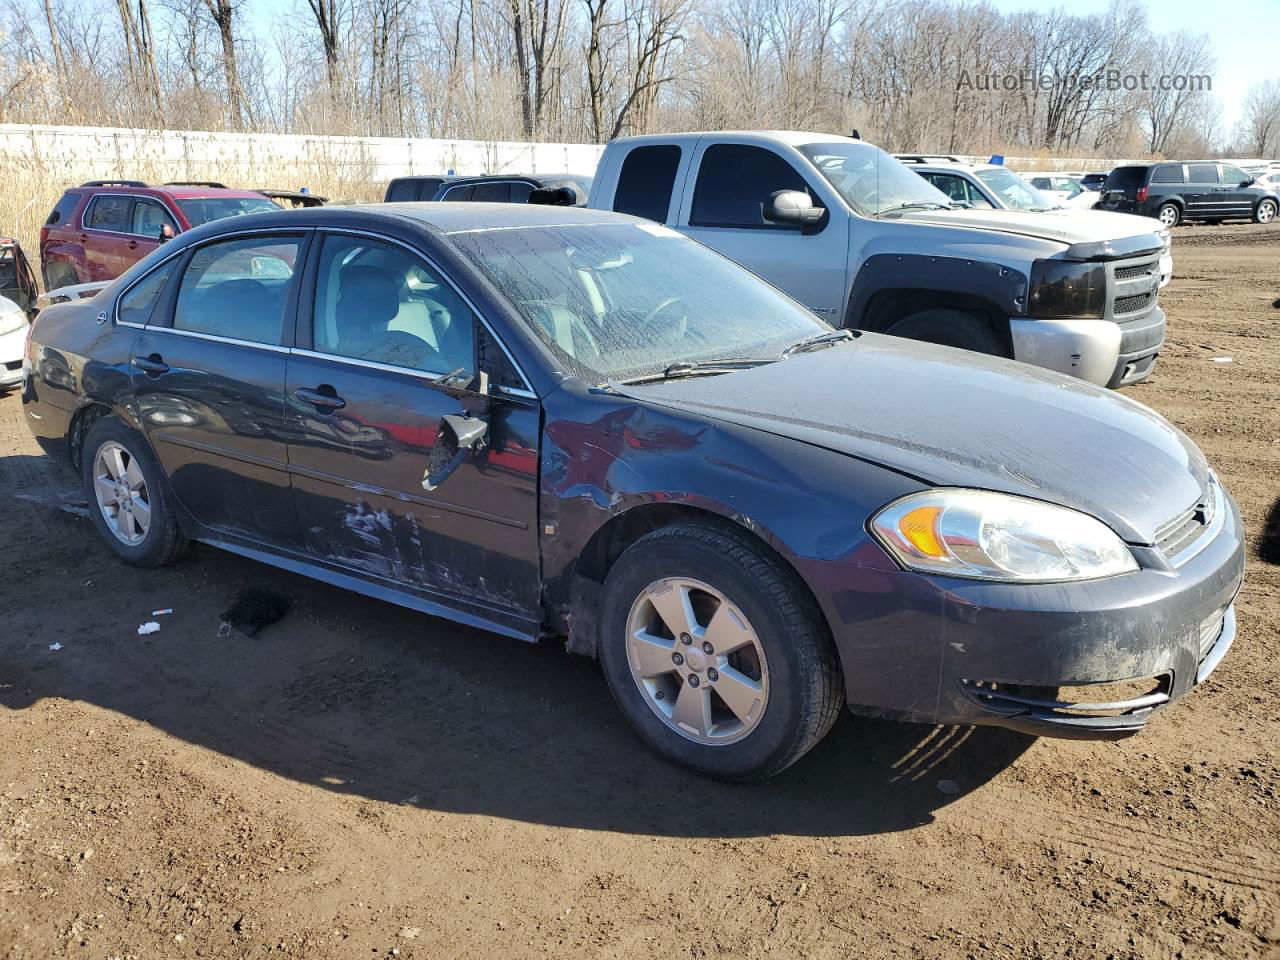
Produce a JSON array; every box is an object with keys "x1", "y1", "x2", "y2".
[{"x1": 0, "y1": 157, "x2": 385, "y2": 289}]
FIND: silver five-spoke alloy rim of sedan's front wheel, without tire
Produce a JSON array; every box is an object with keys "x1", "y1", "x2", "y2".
[{"x1": 627, "y1": 577, "x2": 769, "y2": 746}]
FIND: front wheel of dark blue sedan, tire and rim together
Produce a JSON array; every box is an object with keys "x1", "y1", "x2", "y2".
[{"x1": 600, "y1": 522, "x2": 845, "y2": 780}]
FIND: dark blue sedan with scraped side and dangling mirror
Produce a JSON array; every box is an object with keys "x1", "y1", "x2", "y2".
[{"x1": 23, "y1": 204, "x2": 1243, "y2": 778}]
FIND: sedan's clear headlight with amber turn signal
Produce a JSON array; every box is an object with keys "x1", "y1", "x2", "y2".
[{"x1": 870, "y1": 489, "x2": 1138, "y2": 584}]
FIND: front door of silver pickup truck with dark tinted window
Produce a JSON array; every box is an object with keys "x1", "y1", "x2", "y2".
[{"x1": 676, "y1": 138, "x2": 849, "y2": 324}]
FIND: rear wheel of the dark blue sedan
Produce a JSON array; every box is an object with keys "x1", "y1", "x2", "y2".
[{"x1": 81, "y1": 417, "x2": 187, "y2": 567}]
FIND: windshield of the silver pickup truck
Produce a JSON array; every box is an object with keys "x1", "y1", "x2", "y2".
[{"x1": 800, "y1": 142, "x2": 951, "y2": 216}]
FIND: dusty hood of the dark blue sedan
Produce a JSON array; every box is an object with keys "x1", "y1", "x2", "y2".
[{"x1": 618, "y1": 334, "x2": 1208, "y2": 544}]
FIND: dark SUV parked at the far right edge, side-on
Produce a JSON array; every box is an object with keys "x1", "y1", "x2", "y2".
[{"x1": 1094, "y1": 160, "x2": 1280, "y2": 227}]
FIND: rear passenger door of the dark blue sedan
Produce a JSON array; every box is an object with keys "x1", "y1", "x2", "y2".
[{"x1": 125, "y1": 232, "x2": 307, "y2": 548}]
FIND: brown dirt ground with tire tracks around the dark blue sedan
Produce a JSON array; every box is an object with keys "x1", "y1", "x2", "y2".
[{"x1": 0, "y1": 225, "x2": 1280, "y2": 960}]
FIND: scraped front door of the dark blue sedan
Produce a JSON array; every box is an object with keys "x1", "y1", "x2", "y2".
[{"x1": 285, "y1": 233, "x2": 540, "y2": 634}]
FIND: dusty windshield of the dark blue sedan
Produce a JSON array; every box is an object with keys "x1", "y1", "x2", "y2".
[{"x1": 449, "y1": 223, "x2": 832, "y2": 384}]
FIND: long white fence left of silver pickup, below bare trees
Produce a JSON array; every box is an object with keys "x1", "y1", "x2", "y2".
[{"x1": 0, "y1": 123, "x2": 603, "y2": 187}]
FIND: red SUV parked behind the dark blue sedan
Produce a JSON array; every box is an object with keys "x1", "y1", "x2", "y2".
[{"x1": 40, "y1": 180, "x2": 280, "y2": 291}]
